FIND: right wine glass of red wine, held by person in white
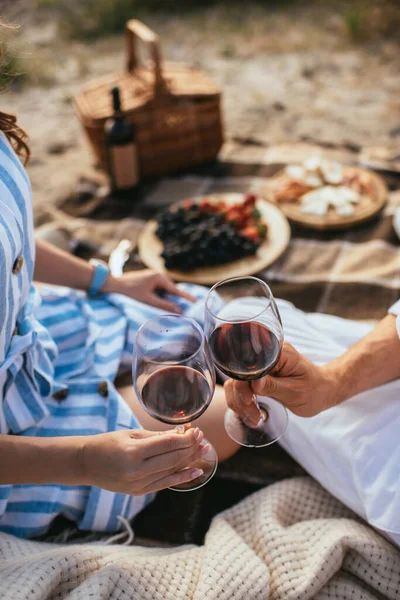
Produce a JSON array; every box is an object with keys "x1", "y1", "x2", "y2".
[{"x1": 205, "y1": 277, "x2": 288, "y2": 448}]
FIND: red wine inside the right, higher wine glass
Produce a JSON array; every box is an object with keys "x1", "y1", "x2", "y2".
[{"x1": 209, "y1": 321, "x2": 281, "y2": 381}]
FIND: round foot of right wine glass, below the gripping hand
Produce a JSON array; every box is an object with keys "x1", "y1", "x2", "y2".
[{"x1": 224, "y1": 398, "x2": 289, "y2": 448}]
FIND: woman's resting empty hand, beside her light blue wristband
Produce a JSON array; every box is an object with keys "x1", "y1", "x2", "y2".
[{"x1": 102, "y1": 269, "x2": 196, "y2": 313}]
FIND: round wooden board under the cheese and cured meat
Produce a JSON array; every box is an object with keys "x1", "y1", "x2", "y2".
[{"x1": 262, "y1": 167, "x2": 388, "y2": 231}]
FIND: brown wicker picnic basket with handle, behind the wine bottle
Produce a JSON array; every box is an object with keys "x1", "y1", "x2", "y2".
[{"x1": 74, "y1": 20, "x2": 223, "y2": 178}]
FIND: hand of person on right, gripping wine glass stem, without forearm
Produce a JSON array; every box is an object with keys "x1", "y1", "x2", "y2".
[{"x1": 224, "y1": 343, "x2": 337, "y2": 427}]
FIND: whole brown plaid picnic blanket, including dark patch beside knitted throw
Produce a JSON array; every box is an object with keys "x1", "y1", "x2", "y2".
[{"x1": 53, "y1": 143, "x2": 400, "y2": 543}]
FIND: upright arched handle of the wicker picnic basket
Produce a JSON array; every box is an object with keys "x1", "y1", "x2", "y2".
[{"x1": 126, "y1": 19, "x2": 164, "y2": 89}]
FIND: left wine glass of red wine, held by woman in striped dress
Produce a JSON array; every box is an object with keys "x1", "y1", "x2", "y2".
[{"x1": 132, "y1": 315, "x2": 218, "y2": 492}]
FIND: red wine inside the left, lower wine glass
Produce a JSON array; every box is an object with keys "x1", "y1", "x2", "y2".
[{"x1": 142, "y1": 366, "x2": 212, "y2": 425}]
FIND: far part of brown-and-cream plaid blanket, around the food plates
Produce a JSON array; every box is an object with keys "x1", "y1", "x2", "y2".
[{"x1": 58, "y1": 144, "x2": 400, "y2": 319}]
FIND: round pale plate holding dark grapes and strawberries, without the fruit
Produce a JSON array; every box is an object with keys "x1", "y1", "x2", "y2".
[{"x1": 138, "y1": 193, "x2": 290, "y2": 285}]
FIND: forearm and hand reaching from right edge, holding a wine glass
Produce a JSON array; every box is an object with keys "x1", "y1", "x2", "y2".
[{"x1": 225, "y1": 315, "x2": 400, "y2": 426}]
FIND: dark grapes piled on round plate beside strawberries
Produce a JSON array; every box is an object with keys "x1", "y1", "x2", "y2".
[{"x1": 156, "y1": 203, "x2": 260, "y2": 271}]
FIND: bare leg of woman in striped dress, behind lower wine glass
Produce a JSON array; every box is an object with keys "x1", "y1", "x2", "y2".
[{"x1": 118, "y1": 385, "x2": 240, "y2": 462}]
